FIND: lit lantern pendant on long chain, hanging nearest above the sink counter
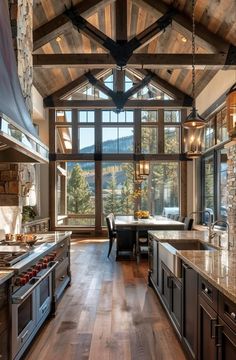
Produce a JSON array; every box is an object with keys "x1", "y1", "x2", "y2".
[{"x1": 182, "y1": 0, "x2": 206, "y2": 158}]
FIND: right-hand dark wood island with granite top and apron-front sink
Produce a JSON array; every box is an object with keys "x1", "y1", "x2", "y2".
[{"x1": 149, "y1": 231, "x2": 236, "y2": 360}]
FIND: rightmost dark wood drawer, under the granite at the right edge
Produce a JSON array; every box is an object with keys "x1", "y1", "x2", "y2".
[{"x1": 219, "y1": 293, "x2": 236, "y2": 332}]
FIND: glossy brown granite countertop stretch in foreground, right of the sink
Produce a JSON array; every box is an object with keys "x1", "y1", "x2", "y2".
[{"x1": 177, "y1": 250, "x2": 236, "y2": 303}]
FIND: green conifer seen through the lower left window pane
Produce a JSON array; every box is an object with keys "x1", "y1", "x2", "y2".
[{"x1": 67, "y1": 165, "x2": 91, "y2": 214}]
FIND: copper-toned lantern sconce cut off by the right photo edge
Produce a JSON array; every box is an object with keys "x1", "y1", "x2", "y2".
[{"x1": 226, "y1": 83, "x2": 236, "y2": 140}]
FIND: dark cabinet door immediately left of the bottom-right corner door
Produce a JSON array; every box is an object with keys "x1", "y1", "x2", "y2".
[{"x1": 198, "y1": 296, "x2": 218, "y2": 360}]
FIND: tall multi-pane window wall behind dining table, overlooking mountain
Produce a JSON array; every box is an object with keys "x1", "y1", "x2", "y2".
[{"x1": 51, "y1": 109, "x2": 184, "y2": 229}]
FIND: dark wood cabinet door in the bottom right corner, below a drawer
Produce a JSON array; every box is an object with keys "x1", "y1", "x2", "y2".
[{"x1": 216, "y1": 318, "x2": 236, "y2": 360}]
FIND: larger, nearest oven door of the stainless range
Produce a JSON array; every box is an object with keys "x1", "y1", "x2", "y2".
[{"x1": 12, "y1": 290, "x2": 37, "y2": 359}]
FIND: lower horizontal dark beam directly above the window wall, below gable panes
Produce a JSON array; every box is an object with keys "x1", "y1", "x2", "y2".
[{"x1": 45, "y1": 100, "x2": 192, "y2": 109}]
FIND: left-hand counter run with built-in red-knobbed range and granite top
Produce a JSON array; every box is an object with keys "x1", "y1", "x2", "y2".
[{"x1": 0, "y1": 231, "x2": 71, "y2": 360}]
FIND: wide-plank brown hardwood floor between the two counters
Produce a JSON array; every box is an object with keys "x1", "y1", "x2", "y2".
[{"x1": 25, "y1": 240, "x2": 185, "y2": 360}]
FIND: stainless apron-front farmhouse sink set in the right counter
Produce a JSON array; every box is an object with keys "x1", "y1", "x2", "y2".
[{"x1": 159, "y1": 240, "x2": 217, "y2": 278}]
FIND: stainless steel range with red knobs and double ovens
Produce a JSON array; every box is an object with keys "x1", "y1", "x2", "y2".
[{"x1": 0, "y1": 243, "x2": 58, "y2": 360}]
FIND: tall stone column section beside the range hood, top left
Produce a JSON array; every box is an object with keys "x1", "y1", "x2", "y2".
[{"x1": 8, "y1": 0, "x2": 33, "y2": 114}]
